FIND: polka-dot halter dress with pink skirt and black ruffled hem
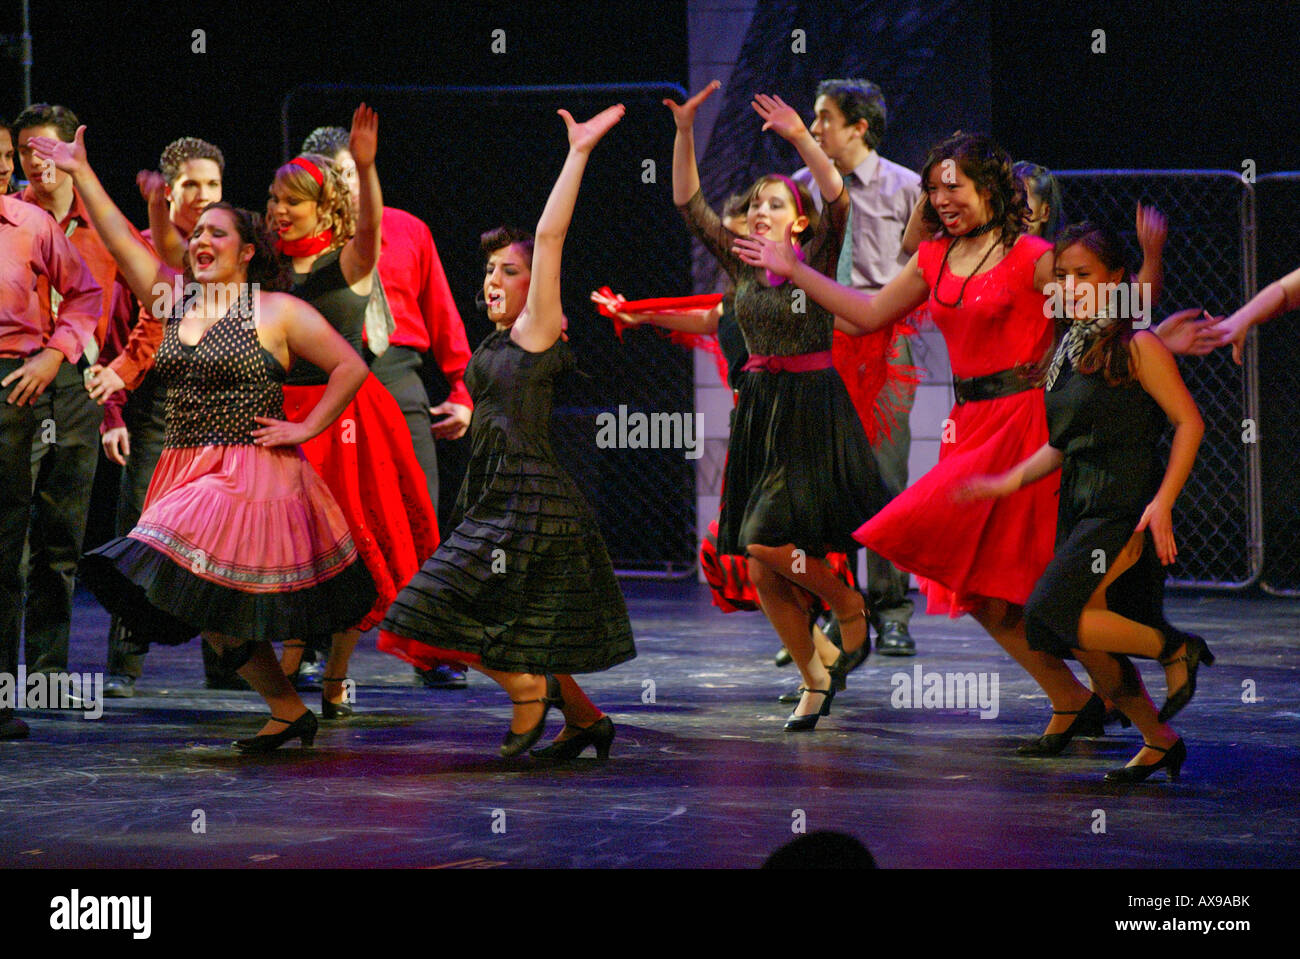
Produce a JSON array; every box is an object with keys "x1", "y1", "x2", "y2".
[{"x1": 81, "y1": 291, "x2": 376, "y2": 645}]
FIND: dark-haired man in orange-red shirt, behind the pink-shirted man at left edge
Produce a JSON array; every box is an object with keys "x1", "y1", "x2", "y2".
[{"x1": 12, "y1": 103, "x2": 139, "y2": 673}]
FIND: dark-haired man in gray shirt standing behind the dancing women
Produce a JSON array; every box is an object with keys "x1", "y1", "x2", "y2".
[{"x1": 794, "y1": 78, "x2": 920, "y2": 656}]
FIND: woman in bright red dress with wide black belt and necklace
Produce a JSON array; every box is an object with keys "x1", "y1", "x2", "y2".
[{"x1": 736, "y1": 134, "x2": 1211, "y2": 755}]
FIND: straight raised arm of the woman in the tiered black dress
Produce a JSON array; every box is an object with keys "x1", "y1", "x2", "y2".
[{"x1": 510, "y1": 103, "x2": 625, "y2": 353}]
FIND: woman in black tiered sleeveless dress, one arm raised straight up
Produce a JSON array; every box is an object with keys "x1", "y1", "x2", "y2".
[{"x1": 381, "y1": 104, "x2": 636, "y2": 759}]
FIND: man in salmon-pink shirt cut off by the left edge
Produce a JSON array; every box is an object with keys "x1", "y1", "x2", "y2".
[{"x1": 0, "y1": 111, "x2": 104, "y2": 739}]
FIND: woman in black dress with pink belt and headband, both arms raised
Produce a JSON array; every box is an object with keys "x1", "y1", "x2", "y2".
[{"x1": 664, "y1": 81, "x2": 884, "y2": 732}]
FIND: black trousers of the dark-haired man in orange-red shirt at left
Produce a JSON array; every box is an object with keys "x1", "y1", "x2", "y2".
[{"x1": 23, "y1": 363, "x2": 104, "y2": 672}]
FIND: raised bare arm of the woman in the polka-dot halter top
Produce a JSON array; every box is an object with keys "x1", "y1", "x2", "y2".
[{"x1": 30, "y1": 126, "x2": 174, "y2": 311}]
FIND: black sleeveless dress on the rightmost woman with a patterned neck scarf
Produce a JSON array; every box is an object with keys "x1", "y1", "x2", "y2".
[{"x1": 1024, "y1": 348, "x2": 1167, "y2": 658}]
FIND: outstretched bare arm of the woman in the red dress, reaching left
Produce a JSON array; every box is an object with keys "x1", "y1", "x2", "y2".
[{"x1": 733, "y1": 227, "x2": 930, "y2": 333}]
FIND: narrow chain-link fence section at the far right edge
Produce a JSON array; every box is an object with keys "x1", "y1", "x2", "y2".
[{"x1": 1255, "y1": 173, "x2": 1300, "y2": 596}]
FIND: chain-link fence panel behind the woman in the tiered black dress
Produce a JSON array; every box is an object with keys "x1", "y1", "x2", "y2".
[{"x1": 282, "y1": 82, "x2": 697, "y2": 576}]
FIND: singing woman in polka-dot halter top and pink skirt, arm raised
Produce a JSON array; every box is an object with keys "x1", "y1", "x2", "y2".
[{"x1": 33, "y1": 127, "x2": 374, "y2": 752}]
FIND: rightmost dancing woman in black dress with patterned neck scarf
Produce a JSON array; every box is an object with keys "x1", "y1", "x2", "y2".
[{"x1": 962, "y1": 224, "x2": 1214, "y2": 782}]
